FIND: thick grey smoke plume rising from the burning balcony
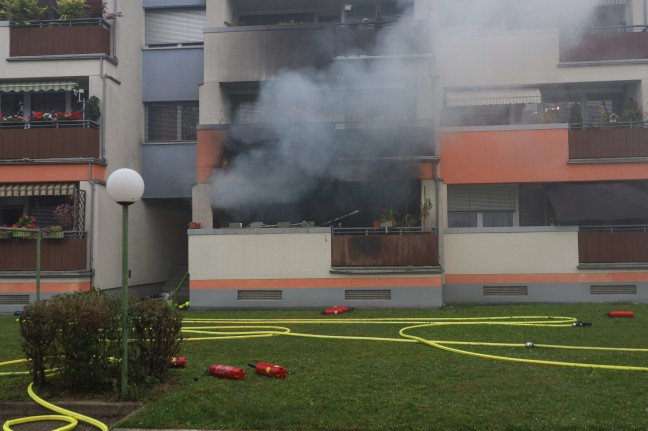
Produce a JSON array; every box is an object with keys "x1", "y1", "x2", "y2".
[{"x1": 211, "y1": 0, "x2": 596, "y2": 220}]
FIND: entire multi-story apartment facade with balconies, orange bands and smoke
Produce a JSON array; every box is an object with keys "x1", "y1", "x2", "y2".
[{"x1": 0, "y1": 0, "x2": 648, "y2": 308}]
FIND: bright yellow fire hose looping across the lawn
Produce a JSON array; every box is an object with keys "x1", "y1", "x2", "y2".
[{"x1": 0, "y1": 316, "x2": 648, "y2": 431}]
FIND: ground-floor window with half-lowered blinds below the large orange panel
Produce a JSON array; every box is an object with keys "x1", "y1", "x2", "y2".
[{"x1": 448, "y1": 185, "x2": 517, "y2": 228}]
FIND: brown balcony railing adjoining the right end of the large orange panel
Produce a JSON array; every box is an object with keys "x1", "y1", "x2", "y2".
[{"x1": 569, "y1": 122, "x2": 648, "y2": 160}]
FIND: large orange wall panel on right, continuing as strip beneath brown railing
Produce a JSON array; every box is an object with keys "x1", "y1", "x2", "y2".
[{"x1": 440, "y1": 128, "x2": 646, "y2": 184}]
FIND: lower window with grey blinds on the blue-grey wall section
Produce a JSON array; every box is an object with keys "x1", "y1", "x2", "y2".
[{"x1": 146, "y1": 102, "x2": 198, "y2": 142}]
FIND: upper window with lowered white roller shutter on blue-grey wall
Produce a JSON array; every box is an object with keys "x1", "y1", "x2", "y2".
[{"x1": 145, "y1": 8, "x2": 206, "y2": 48}]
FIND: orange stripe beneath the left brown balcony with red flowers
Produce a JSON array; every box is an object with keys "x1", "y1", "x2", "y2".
[{"x1": 0, "y1": 164, "x2": 106, "y2": 183}]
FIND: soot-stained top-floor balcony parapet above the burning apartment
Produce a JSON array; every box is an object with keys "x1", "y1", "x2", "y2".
[{"x1": 205, "y1": 21, "x2": 431, "y2": 82}]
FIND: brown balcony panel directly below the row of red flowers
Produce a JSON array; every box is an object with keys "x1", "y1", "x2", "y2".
[{"x1": 0, "y1": 120, "x2": 99, "y2": 160}]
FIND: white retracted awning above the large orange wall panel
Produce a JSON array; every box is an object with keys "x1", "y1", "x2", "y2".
[{"x1": 446, "y1": 88, "x2": 542, "y2": 108}]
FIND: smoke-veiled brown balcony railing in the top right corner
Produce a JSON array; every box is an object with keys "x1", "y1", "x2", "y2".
[{"x1": 559, "y1": 25, "x2": 648, "y2": 63}]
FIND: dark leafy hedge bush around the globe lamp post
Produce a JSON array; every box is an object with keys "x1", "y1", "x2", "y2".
[{"x1": 19, "y1": 290, "x2": 182, "y2": 392}]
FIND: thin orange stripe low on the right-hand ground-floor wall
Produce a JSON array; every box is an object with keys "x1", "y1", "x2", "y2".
[{"x1": 445, "y1": 272, "x2": 648, "y2": 284}]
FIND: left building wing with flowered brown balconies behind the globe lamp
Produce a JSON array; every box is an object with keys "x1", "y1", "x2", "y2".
[{"x1": 0, "y1": 1, "x2": 189, "y2": 311}]
